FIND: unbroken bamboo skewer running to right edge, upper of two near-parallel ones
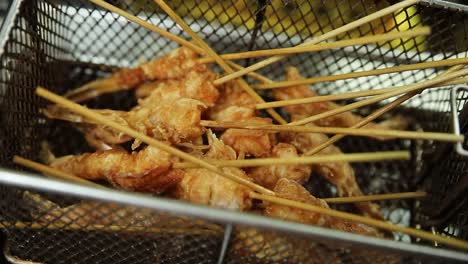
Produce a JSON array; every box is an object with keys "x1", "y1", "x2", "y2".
[{"x1": 253, "y1": 58, "x2": 468, "y2": 90}]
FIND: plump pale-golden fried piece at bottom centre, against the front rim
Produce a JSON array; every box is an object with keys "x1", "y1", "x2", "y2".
[{"x1": 174, "y1": 135, "x2": 252, "y2": 211}]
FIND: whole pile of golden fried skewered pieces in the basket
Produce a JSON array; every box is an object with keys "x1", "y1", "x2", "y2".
[{"x1": 39, "y1": 47, "x2": 405, "y2": 260}]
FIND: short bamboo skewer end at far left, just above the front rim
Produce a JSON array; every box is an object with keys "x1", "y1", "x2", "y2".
[{"x1": 13, "y1": 155, "x2": 105, "y2": 188}]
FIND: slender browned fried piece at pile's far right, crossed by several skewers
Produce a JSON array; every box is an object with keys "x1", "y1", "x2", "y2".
[{"x1": 280, "y1": 117, "x2": 383, "y2": 219}]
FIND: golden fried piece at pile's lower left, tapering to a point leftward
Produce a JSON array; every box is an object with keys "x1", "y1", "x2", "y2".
[{"x1": 50, "y1": 146, "x2": 183, "y2": 193}]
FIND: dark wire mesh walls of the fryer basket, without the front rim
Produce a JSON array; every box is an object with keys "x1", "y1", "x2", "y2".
[{"x1": 0, "y1": 0, "x2": 468, "y2": 263}]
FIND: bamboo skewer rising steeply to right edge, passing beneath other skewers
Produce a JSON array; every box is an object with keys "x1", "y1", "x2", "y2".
[{"x1": 304, "y1": 65, "x2": 463, "y2": 156}]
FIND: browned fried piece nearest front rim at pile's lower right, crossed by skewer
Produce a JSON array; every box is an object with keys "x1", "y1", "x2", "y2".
[{"x1": 265, "y1": 178, "x2": 381, "y2": 236}]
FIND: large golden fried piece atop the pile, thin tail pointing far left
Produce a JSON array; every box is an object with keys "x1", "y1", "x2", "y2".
[{"x1": 43, "y1": 70, "x2": 219, "y2": 148}]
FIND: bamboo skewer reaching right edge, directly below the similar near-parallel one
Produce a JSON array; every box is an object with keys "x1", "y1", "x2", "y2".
[{"x1": 255, "y1": 77, "x2": 468, "y2": 110}]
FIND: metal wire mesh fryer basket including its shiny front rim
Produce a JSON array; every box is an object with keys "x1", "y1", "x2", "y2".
[{"x1": 0, "y1": 0, "x2": 468, "y2": 263}]
